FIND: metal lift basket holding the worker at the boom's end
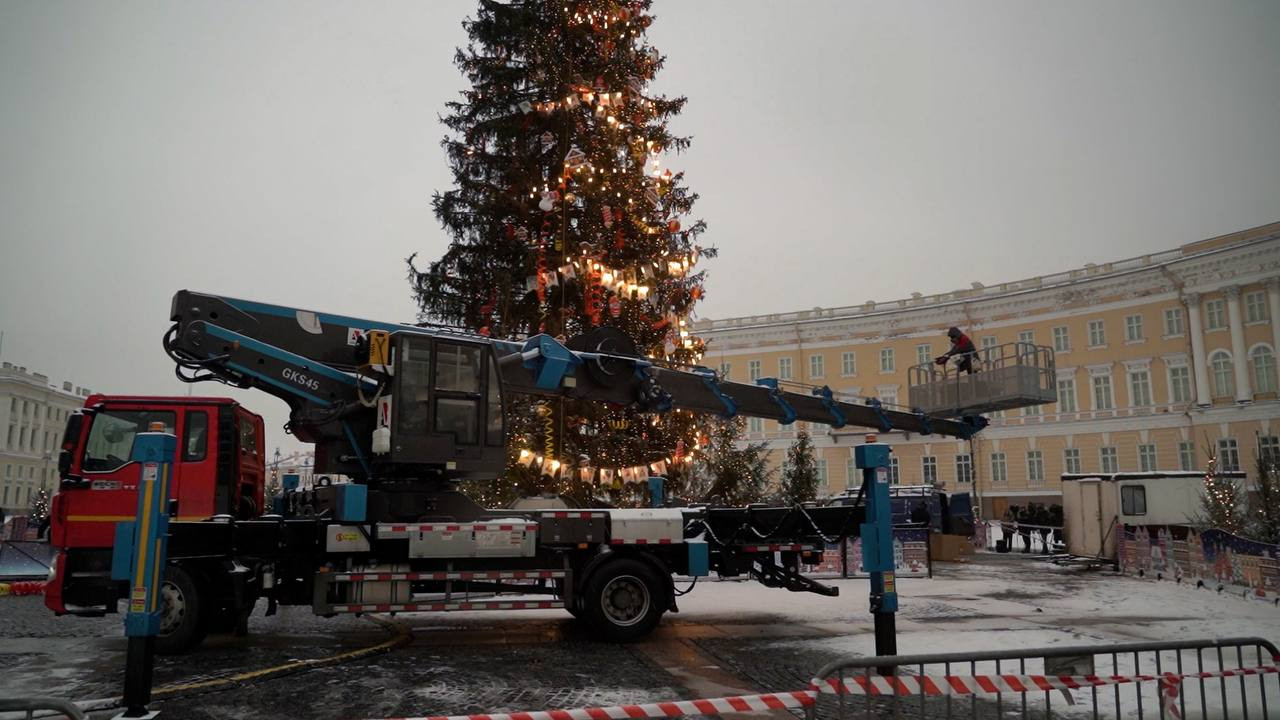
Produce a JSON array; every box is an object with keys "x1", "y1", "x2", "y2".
[{"x1": 908, "y1": 342, "x2": 1057, "y2": 416}]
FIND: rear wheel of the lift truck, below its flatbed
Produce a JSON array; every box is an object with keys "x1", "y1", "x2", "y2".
[{"x1": 582, "y1": 557, "x2": 663, "y2": 642}]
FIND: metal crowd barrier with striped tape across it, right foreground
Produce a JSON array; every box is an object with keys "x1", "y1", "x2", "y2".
[{"x1": 805, "y1": 638, "x2": 1280, "y2": 720}]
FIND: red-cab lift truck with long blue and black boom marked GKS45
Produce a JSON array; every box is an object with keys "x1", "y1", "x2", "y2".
[{"x1": 46, "y1": 290, "x2": 1008, "y2": 652}]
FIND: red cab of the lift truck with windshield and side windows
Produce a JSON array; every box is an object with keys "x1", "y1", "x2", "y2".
[{"x1": 45, "y1": 395, "x2": 266, "y2": 615}]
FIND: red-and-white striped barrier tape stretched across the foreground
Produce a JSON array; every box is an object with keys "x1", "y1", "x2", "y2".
[{"x1": 368, "y1": 659, "x2": 1280, "y2": 720}]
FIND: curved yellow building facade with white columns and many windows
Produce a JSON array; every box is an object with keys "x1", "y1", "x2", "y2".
[{"x1": 695, "y1": 223, "x2": 1280, "y2": 518}]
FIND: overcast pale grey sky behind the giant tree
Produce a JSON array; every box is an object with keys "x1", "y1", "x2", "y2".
[{"x1": 0, "y1": 0, "x2": 1280, "y2": 450}]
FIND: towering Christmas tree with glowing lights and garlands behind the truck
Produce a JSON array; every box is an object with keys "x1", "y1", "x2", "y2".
[{"x1": 410, "y1": 0, "x2": 713, "y2": 503}]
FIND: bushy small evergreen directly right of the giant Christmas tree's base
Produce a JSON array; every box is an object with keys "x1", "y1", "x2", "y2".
[{"x1": 701, "y1": 418, "x2": 773, "y2": 506}]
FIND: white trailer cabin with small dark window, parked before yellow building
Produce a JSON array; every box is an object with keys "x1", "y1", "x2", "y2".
[{"x1": 1062, "y1": 471, "x2": 1245, "y2": 561}]
